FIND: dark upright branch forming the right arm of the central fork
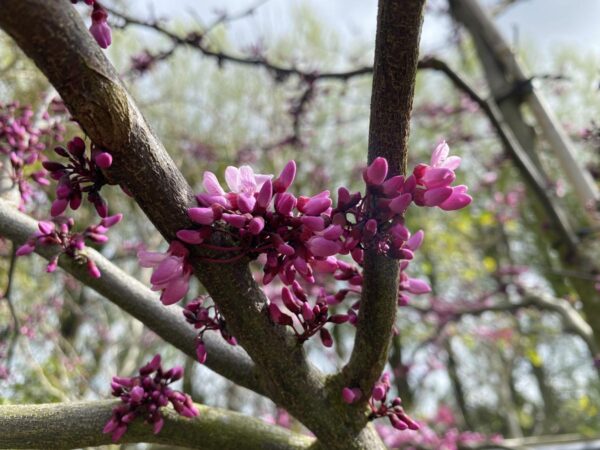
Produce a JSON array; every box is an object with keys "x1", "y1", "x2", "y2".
[{"x1": 342, "y1": 0, "x2": 424, "y2": 394}]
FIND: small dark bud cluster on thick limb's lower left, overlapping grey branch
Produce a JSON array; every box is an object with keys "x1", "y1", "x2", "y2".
[{"x1": 183, "y1": 297, "x2": 237, "y2": 364}]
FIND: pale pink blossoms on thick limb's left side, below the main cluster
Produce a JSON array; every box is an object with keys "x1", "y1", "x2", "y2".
[{"x1": 137, "y1": 241, "x2": 192, "y2": 305}]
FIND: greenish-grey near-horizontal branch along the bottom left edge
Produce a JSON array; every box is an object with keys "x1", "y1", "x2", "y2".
[{"x1": 0, "y1": 400, "x2": 313, "y2": 450}]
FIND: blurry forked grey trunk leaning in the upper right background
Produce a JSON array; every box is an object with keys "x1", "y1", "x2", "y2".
[{"x1": 450, "y1": 0, "x2": 600, "y2": 347}]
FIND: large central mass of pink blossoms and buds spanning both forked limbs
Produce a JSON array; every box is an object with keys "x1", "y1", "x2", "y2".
[{"x1": 140, "y1": 142, "x2": 471, "y2": 356}]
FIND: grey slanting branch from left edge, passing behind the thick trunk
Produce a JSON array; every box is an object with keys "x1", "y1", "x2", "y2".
[{"x1": 0, "y1": 199, "x2": 264, "y2": 393}]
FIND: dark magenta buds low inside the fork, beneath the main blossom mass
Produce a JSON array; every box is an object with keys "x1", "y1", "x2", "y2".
[{"x1": 269, "y1": 280, "x2": 350, "y2": 347}]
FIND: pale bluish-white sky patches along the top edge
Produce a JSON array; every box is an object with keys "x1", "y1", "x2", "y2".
[{"x1": 120, "y1": 0, "x2": 600, "y2": 54}]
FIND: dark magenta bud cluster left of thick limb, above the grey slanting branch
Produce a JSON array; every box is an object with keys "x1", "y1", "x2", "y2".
[{"x1": 43, "y1": 137, "x2": 112, "y2": 217}]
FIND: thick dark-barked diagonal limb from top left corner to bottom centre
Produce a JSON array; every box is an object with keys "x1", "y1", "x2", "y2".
[{"x1": 0, "y1": 0, "x2": 384, "y2": 449}]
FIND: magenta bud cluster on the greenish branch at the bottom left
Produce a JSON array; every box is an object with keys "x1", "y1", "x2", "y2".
[{"x1": 103, "y1": 355, "x2": 198, "y2": 442}]
